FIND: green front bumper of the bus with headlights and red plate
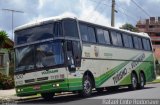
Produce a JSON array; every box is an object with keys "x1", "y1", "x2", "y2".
[{"x1": 16, "y1": 80, "x2": 69, "y2": 96}]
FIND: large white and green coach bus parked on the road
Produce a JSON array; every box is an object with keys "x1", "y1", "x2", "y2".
[{"x1": 15, "y1": 17, "x2": 155, "y2": 100}]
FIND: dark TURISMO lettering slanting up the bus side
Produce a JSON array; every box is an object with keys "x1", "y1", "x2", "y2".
[{"x1": 113, "y1": 68, "x2": 127, "y2": 84}]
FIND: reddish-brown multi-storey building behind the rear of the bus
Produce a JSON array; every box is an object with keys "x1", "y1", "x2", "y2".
[{"x1": 136, "y1": 17, "x2": 160, "y2": 63}]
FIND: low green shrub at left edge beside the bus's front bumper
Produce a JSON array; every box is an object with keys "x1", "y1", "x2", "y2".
[{"x1": 0, "y1": 73, "x2": 14, "y2": 89}]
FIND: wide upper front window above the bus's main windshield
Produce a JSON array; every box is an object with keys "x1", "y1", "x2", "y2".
[{"x1": 15, "y1": 24, "x2": 53, "y2": 45}]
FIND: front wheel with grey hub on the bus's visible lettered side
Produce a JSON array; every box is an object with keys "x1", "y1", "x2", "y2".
[{"x1": 81, "y1": 75, "x2": 93, "y2": 97}]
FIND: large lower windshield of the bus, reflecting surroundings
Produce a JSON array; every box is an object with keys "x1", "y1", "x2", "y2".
[{"x1": 16, "y1": 41, "x2": 64, "y2": 71}]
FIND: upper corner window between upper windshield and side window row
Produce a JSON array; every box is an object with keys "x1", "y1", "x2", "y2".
[{"x1": 63, "y1": 20, "x2": 78, "y2": 38}]
